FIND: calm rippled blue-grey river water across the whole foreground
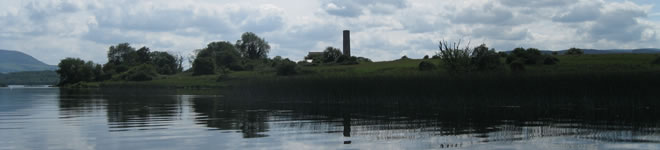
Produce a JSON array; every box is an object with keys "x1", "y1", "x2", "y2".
[{"x1": 0, "y1": 88, "x2": 660, "y2": 150}]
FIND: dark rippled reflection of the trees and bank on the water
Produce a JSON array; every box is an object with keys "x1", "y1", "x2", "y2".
[{"x1": 45, "y1": 89, "x2": 660, "y2": 149}]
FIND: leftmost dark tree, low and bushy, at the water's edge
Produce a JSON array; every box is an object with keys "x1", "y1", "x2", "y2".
[{"x1": 56, "y1": 58, "x2": 98, "y2": 85}]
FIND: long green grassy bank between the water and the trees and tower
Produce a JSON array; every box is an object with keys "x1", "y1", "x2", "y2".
[{"x1": 77, "y1": 54, "x2": 660, "y2": 89}]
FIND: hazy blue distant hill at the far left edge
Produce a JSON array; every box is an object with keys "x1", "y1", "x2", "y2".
[{"x1": 0, "y1": 50, "x2": 57, "y2": 73}]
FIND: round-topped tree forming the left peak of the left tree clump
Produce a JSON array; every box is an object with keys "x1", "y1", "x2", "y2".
[{"x1": 108, "y1": 43, "x2": 138, "y2": 66}]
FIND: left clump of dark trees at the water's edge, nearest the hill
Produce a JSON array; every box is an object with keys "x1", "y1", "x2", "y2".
[{"x1": 56, "y1": 43, "x2": 183, "y2": 85}]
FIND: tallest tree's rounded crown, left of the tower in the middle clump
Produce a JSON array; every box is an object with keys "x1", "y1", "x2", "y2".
[{"x1": 236, "y1": 32, "x2": 270, "y2": 59}]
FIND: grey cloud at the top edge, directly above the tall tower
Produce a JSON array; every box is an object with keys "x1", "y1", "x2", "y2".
[{"x1": 321, "y1": 0, "x2": 408, "y2": 17}]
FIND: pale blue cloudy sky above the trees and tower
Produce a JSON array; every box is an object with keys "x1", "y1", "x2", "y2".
[{"x1": 0, "y1": 0, "x2": 660, "y2": 65}]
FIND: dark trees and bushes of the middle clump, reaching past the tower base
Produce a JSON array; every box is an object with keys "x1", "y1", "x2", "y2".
[{"x1": 190, "y1": 32, "x2": 371, "y2": 75}]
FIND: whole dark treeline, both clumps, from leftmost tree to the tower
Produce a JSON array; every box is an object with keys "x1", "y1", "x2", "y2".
[{"x1": 57, "y1": 32, "x2": 371, "y2": 85}]
